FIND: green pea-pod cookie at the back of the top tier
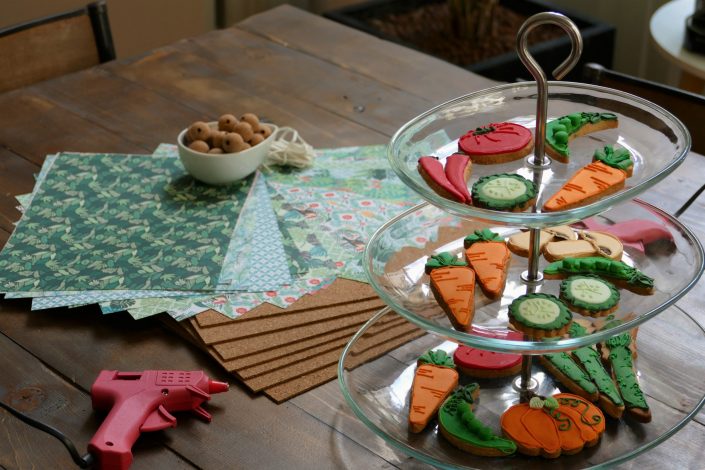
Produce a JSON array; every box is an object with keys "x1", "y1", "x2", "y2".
[{"x1": 546, "y1": 112, "x2": 619, "y2": 163}]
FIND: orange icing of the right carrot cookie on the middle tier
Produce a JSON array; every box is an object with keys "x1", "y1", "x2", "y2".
[{"x1": 465, "y1": 242, "x2": 510, "y2": 299}]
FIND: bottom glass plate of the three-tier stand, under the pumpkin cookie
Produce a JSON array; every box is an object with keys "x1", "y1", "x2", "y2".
[{"x1": 338, "y1": 308, "x2": 705, "y2": 470}]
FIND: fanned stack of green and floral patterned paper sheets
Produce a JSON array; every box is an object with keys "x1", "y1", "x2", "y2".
[{"x1": 0, "y1": 144, "x2": 418, "y2": 320}]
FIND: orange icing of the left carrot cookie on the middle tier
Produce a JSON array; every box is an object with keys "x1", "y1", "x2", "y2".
[{"x1": 430, "y1": 266, "x2": 475, "y2": 327}]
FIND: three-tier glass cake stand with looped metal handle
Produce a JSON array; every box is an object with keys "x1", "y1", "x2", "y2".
[{"x1": 338, "y1": 13, "x2": 705, "y2": 469}]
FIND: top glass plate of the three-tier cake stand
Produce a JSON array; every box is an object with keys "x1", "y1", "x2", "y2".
[{"x1": 388, "y1": 82, "x2": 690, "y2": 227}]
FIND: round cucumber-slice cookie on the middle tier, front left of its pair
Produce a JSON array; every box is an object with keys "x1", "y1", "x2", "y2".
[{"x1": 509, "y1": 293, "x2": 573, "y2": 339}]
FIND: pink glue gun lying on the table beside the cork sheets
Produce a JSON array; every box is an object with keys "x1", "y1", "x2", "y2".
[{"x1": 88, "y1": 370, "x2": 229, "y2": 470}]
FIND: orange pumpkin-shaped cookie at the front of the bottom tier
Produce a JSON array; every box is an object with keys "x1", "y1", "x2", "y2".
[{"x1": 501, "y1": 393, "x2": 605, "y2": 459}]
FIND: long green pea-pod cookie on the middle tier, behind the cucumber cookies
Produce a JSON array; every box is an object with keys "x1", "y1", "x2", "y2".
[{"x1": 543, "y1": 257, "x2": 654, "y2": 289}]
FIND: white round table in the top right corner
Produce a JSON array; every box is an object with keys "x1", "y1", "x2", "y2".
[{"x1": 649, "y1": 0, "x2": 705, "y2": 93}]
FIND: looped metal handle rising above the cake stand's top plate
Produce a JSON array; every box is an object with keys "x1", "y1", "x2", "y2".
[{"x1": 517, "y1": 12, "x2": 583, "y2": 167}]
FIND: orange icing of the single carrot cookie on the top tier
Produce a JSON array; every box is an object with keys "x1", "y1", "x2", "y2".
[{"x1": 543, "y1": 161, "x2": 627, "y2": 211}]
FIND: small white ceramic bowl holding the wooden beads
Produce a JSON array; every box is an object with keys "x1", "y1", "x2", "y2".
[{"x1": 177, "y1": 121, "x2": 278, "y2": 185}]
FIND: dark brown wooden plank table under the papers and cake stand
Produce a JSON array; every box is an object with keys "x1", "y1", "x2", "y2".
[{"x1": 0, "y1": 6, "x2": 705, "y2": 469}]
